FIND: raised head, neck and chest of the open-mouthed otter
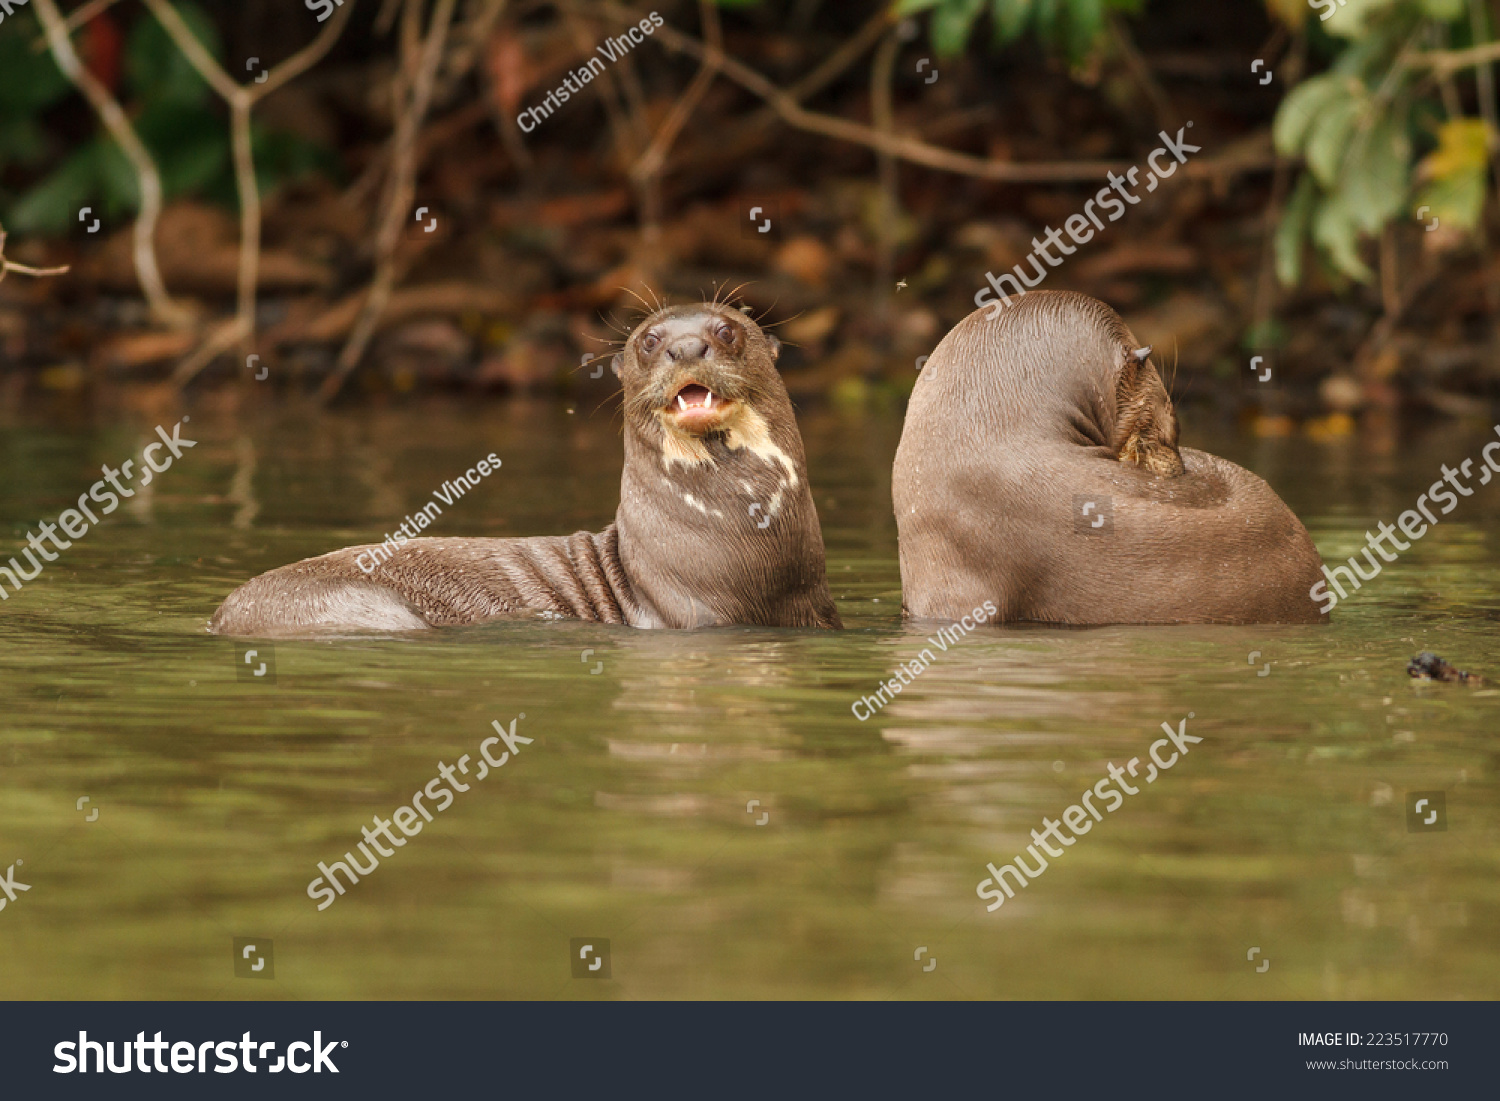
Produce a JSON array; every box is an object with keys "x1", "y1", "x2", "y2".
[{"x1": 614, "y1": 303, "x2": 839, "y2": 627}]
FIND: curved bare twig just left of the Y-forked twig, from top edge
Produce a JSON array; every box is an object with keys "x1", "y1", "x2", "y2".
[{"x1": 36, "y1": 0, "x2": 194, "y2": 329}]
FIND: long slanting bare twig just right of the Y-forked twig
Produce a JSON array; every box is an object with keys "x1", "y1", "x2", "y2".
[{"x1": 318, "y1": 0, "x2": 456, "y2": 402}]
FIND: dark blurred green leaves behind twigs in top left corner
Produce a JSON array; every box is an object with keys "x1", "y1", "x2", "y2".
[{"x1": 0, "y1": 3, "x2": 332, "y2": 234}]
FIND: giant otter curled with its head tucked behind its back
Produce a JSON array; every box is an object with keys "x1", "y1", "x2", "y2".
[{"x1": 891, "y1": 291, "x2": 1328, "y2": 624}]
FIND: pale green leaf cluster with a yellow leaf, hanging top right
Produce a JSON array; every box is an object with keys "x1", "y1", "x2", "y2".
[{"x1": 1272, "y1": 0, "x2": 1493, "y2": 285}]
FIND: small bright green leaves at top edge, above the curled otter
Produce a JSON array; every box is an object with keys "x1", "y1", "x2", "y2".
[{"x1": 896, "y1": 0, "x2": 1140, "y2": 65}]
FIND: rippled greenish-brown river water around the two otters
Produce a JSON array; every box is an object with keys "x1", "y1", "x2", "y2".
[{"x1": 0, "y1": 402, "x2": 1500, "y2": 998}]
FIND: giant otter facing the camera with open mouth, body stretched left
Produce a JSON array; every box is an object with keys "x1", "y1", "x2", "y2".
[{"x1": 209, "y1": 305, "x2": 843, "y2": 636}]
